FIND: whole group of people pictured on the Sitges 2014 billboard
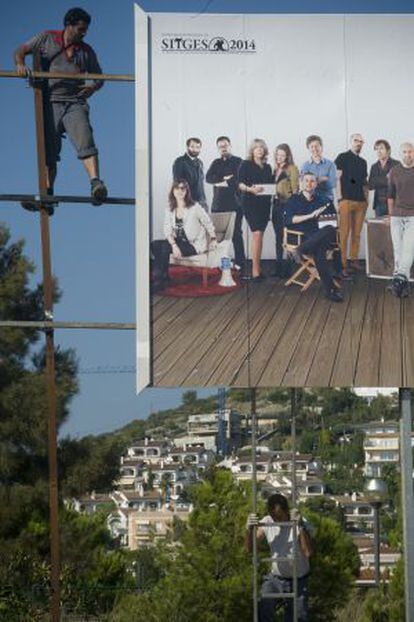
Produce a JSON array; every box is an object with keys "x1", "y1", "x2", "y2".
[{"x1": 151, "y1": 134, "x2": 414, "y2": 302}]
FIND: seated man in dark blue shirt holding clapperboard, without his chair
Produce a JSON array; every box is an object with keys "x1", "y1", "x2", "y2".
[{"x1": 284, "y1": 171, "x2": 343, "y2": 302}]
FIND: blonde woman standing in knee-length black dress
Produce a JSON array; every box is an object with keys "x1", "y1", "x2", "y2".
[{"x1": 238, "y1": 138, "x2": 274, "y2": 281}]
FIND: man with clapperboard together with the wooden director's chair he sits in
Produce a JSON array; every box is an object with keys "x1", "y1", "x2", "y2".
[{"x1": 284, "y1": 172, "x2": 344, "y2": 302}]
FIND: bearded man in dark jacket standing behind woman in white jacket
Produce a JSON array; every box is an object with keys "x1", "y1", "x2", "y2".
[{"x1": 173, "y1": 137, "x2": 208, "y2": 211}]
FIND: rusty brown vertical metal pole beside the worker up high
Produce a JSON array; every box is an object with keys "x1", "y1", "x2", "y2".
[{"x1": 33, "y1": 54, "x2": 60, "y2": 622}]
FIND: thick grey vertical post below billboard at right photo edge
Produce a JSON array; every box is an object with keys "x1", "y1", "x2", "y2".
[{"x1": 399, "y1": 389, "x2": 414, "y2": 622}]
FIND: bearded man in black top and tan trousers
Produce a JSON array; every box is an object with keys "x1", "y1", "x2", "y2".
[{"x1": 335, "y1": 134, "x2": 368, "y2": 272}]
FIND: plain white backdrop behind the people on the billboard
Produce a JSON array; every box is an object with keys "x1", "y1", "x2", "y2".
[{"x1": 148, "y1": 13, "x2": 414, "y2": 258}]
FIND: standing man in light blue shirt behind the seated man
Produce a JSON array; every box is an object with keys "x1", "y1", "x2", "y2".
[{"x1": 300, "y1": 134, "x2": 336, "y2": 203}]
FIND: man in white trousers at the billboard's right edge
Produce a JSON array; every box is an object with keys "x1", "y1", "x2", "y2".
[{"x1": 388, "y1": 143, "x2": 414, "y2": 298}]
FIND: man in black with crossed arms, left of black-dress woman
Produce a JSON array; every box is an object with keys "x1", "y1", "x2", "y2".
[{"x1": 206, "y1": 136, "x2": 246, "y2": 269}]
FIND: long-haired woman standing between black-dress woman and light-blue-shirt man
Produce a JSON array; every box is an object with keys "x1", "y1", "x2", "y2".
[{"x1": 272, "y1": 143, "x2": 299, "y2": 278}]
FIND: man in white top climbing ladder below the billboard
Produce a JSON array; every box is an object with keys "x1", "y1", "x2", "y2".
[{"x1": 246, "y1": 493, "x2": 312, "y2": 622}]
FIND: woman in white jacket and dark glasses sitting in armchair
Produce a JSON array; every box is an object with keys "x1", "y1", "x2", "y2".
[{"x1": 151, "y1": 180, "x2": 217, "y2": 291}]
